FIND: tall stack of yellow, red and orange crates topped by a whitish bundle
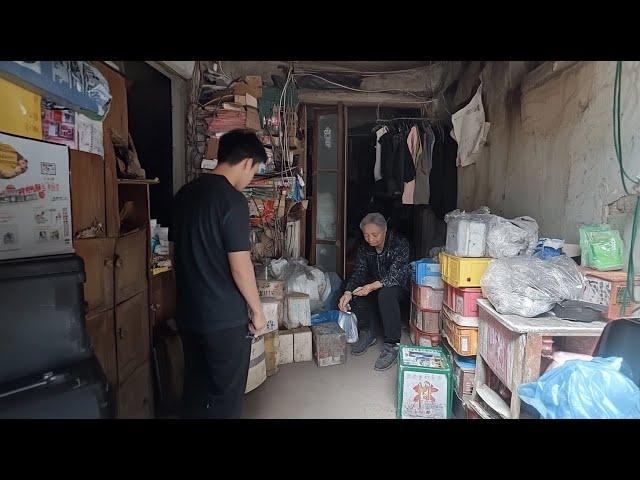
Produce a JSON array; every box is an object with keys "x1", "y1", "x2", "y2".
[{"x1": 439, "y1": 219, "x2": 491, "y2": 411}]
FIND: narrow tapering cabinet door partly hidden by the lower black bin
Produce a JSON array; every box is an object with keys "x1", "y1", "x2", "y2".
[{"x1": 86, "y1": 310, "x2": 118, "y2": 388}]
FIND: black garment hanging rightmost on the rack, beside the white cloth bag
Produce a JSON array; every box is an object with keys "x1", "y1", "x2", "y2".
[{"x1": 429, "y1": 125, "x2": 458, "y2": 219}]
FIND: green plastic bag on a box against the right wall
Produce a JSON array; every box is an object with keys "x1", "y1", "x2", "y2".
[{"x1": 580, "y1": 224, "x2": 624, "y2": 271}]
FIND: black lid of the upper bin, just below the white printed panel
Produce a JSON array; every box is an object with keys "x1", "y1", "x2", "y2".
[{"x1": 0, "y1": 253, "x2": 84, "y2": 282}]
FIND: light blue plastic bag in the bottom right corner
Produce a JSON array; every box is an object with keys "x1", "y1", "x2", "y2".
[{"x1": 518, "y1": 357, "x2": 640, "y2": 419}]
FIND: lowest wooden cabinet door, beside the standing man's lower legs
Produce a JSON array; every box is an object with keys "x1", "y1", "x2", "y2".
[{"x1": 118, "y1": 362, "x2": 153, "y2": 418}]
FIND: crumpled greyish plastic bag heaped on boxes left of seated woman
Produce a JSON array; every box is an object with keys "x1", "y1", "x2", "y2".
[{"x1": 269, "y1": 258, "x2": 331, "y2": 313}]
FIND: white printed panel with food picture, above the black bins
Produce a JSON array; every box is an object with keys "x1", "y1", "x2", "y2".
[{"x1": 0, "y1": 132, "x2": 74, "y2": 260}]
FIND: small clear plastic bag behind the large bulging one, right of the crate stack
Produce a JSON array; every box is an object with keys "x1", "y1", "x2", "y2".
[{"x1": 486, "y1": 216, "x2": 538, "y2": 258}]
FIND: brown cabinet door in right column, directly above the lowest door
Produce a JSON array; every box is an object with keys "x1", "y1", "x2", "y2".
[{"x1": 116, "y1": 292, "x2": 150, "y2": 384}]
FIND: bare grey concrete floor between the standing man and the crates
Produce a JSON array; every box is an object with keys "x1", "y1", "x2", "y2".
[{"x1": 243, "y1": 329, "x2": 410, "y2": 419}]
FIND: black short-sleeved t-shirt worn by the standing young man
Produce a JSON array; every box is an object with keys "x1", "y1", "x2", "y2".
[{"x1": 173, "y1": 174, "x2": 251, "y2": 332}]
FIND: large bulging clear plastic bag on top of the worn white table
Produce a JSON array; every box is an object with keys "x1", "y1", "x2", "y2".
[{"x1": 480, "y1": 255, "x2": 585, "y2": 317}]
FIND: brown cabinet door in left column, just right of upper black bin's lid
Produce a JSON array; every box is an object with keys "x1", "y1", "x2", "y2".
[{"x1": 74, "y1": 238, "x2": 116, "y2": 312}]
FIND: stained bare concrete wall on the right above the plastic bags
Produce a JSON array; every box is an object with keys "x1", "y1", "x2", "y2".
[{"x1": 458, "y1": 62, "x2": 640, "y2": 253}]
